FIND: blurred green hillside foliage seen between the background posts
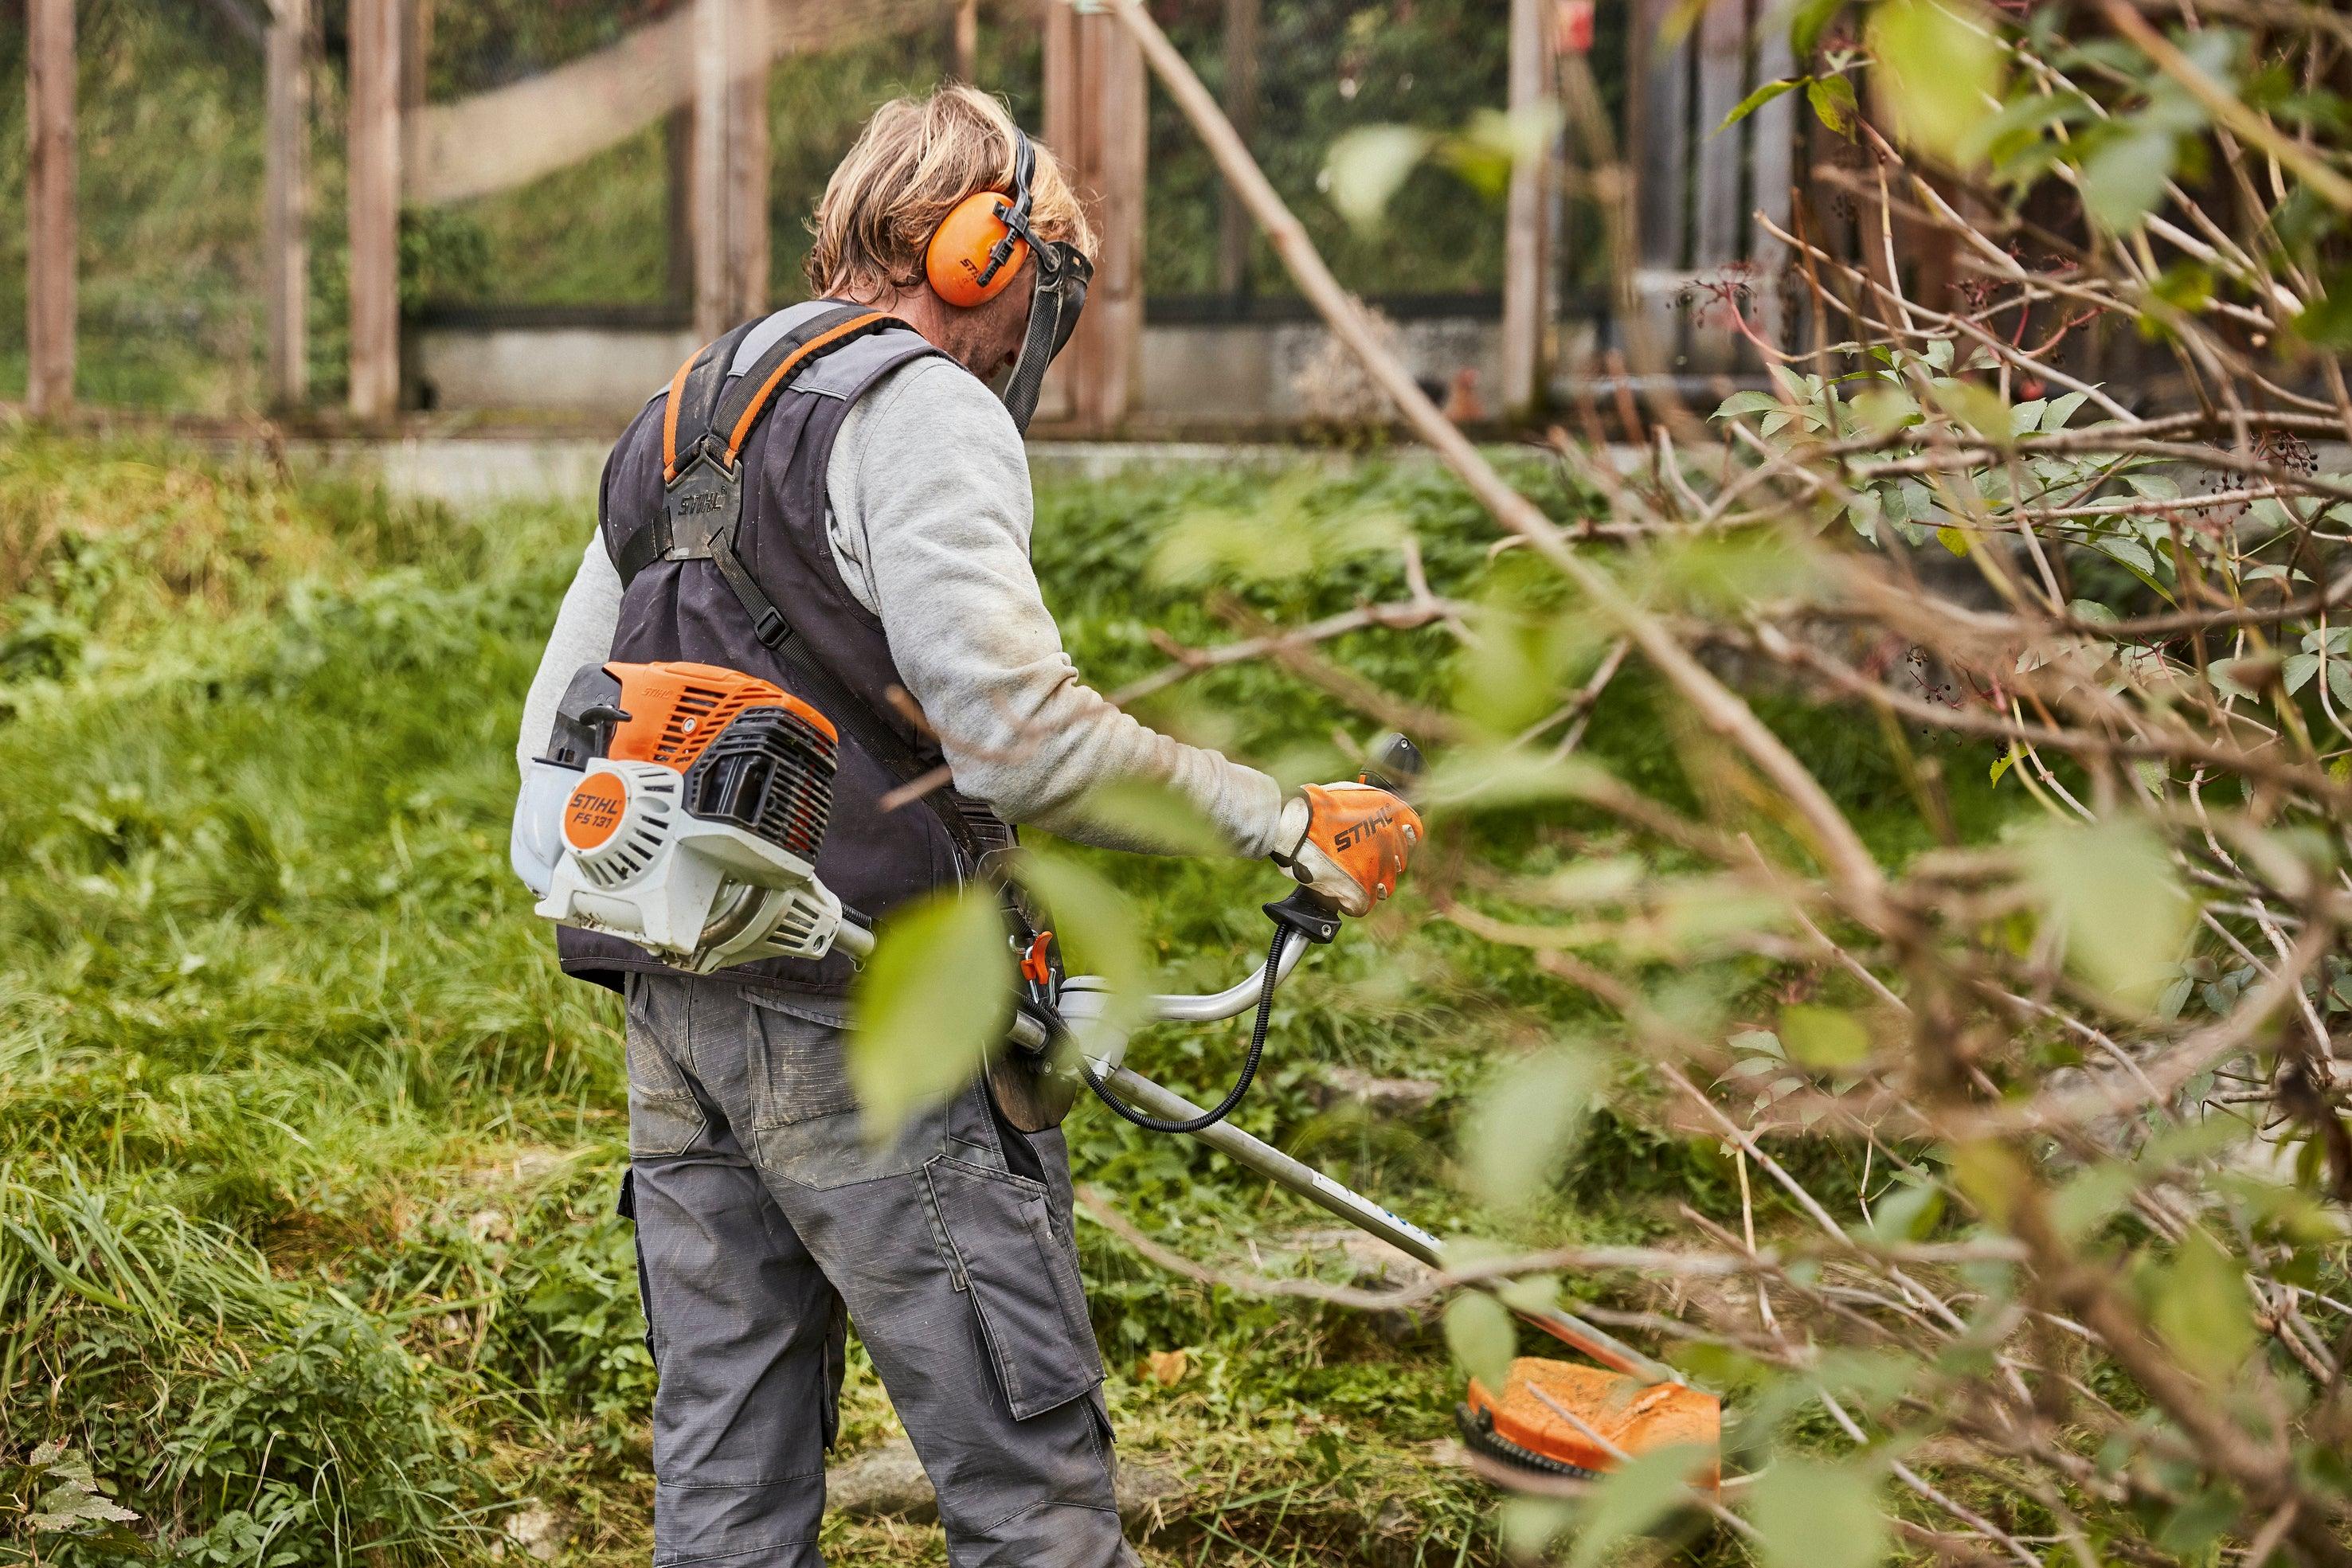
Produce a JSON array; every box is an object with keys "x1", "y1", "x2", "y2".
[{"x1": 0, "y1": 0, "x2": 1552, "y2": 414}]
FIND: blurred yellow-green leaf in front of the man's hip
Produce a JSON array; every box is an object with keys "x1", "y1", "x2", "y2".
[{"x1": 849, "y1": 891, "x2": 1014, "y2": 1148}]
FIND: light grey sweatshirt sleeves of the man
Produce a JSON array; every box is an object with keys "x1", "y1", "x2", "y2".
[{"x1": 515, "y1": 358, "x2": 1282, "y2": 856}]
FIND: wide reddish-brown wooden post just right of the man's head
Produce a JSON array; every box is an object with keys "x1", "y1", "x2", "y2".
[{"x1": 1039, "y1": 2, "x2": 1150, "y2": 432}]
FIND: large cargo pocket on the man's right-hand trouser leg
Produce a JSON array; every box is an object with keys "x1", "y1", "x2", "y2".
[{"x1": 922, "y1": 1154, "x2": 1103, "y2": 1420}]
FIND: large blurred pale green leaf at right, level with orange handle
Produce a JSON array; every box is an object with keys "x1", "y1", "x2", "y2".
[{"x1": 2029, "y1": 820, "x2": 2197, "y2": 1008}]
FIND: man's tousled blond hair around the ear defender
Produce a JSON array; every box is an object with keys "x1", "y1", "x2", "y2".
[{"x1": 804, "y1": 82, "x2": 1094, "y2": 299}]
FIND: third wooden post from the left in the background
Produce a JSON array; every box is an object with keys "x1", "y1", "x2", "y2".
[{"x1": 348, "y1": 0, "x2": 400, "y2": 420}]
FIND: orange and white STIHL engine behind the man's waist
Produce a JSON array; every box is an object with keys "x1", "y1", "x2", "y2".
[{"x1": 513, "y1": 663, "x2": 873, "y2": 976}]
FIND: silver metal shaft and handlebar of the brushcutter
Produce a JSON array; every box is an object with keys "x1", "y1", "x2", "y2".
[{"x1": 1014, "y1": 936, "x2": 1681, "y2": 1382}]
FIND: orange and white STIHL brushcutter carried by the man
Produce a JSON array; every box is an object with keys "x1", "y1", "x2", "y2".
[{"x1": 513, "y1": 663, "x2": 1722, "y2": 1486}]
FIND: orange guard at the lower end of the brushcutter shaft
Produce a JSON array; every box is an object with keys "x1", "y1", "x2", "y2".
[{"x1": 1470, "y1": 1356, "x2": 1724, "y2": 1491}]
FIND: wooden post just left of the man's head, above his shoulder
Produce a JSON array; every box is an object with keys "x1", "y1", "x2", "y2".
[{"x1": 689, "y1": 0, "x2": 769, "y2": 338}]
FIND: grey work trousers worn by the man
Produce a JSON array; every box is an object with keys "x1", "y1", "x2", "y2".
[{"x1": 624, "y1": 976, "x2": 1136, "y2": 1568}]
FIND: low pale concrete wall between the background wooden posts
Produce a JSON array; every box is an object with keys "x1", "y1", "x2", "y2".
[{"x1": 412, "y1": 318, "x2": 1501, "y2": 430}]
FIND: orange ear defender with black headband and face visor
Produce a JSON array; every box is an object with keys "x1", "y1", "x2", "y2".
[{"x1": 922, "y1": 127, "x2": 1094, "y2": 430}]
